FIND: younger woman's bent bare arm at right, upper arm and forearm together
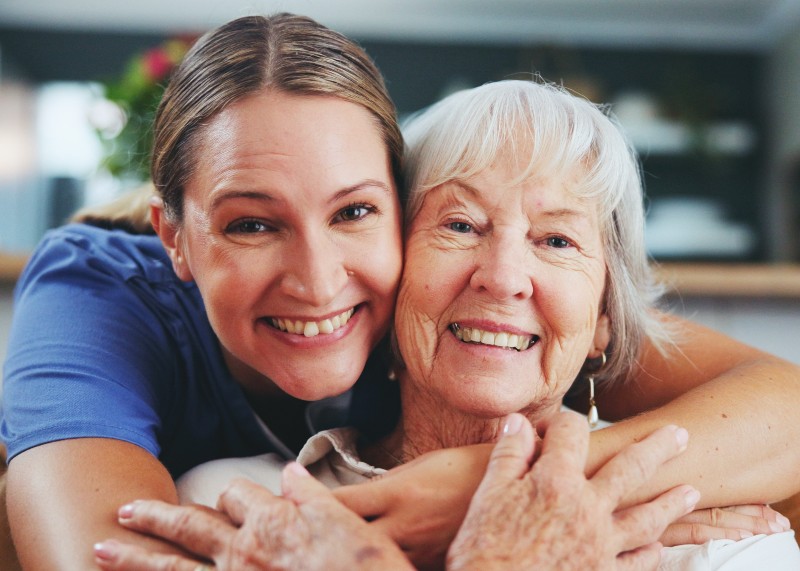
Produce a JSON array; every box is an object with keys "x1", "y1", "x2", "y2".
[{"x1": 587, "y1": 318, "x2": 800, "y2": 507}]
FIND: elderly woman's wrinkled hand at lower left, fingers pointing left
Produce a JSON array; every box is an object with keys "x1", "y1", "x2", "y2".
[{"x1": 95, "y1": 463, "x2": 413, "y2": 571}]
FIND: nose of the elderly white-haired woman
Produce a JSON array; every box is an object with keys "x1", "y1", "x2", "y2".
[{"x1": 470, "y1": 230, "x2": 533, "y2": 300}]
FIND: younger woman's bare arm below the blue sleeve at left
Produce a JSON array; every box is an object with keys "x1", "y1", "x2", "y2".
[{"x1": 8, "y1": 439, "x2": 183, "y2": 571}]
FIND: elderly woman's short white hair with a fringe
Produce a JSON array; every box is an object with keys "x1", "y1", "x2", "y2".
[{"x1": 403, "y1": 80, "x2": 669, "y2": 379}]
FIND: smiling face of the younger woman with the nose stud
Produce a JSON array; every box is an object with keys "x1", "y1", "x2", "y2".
[{"x1": 161, "y1": 91, "x2": 402, "y2": 400}]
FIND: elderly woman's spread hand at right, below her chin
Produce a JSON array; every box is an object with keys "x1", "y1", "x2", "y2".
[{"x1": 447, "y1": 413, "x2": 699, "y2": 571}]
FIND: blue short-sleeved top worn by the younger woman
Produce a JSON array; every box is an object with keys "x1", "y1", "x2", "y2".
[{"x1": 0, "y1": 224, "x2": 285, "y2": 477}]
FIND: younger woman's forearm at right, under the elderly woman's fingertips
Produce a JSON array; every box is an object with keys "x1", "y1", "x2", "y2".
[{"x1": 587, "y1": 357, "x2": 800, "y2": 507}]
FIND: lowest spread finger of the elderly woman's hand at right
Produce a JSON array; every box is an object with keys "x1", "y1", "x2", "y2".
[{"x1": 614, "y1": 486, "x2": 700, "y2": 552}]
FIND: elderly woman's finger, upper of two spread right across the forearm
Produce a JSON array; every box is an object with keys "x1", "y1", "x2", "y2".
[{"x1": 592, "y1": 425, "x2": 689, "y2": 504}]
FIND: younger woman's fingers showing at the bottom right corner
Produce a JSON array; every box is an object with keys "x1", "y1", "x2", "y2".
[{"x1": 661, "y1": 504, "x2": 791, "y2": 547}]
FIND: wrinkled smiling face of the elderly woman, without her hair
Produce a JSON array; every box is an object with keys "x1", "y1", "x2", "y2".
[{"x1": 395, "y1": 154, "x2": 608, "y2": 417}]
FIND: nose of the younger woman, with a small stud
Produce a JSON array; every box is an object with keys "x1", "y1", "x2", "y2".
[{"x1": 281, "y1": 231, "x2": 348, "y2": 307}]
